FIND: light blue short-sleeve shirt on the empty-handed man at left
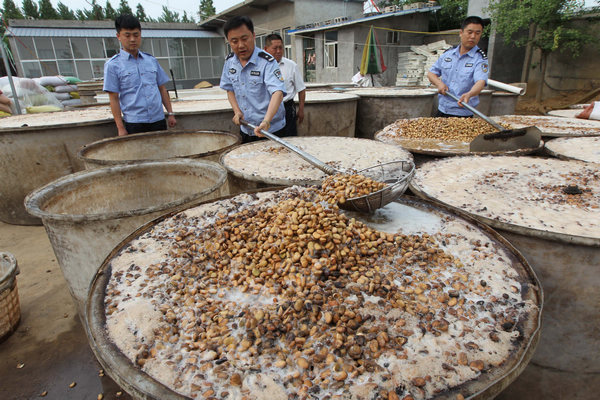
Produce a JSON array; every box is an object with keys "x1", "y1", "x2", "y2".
[{"x1": 104, "y1": 49, "x2": 169, "y2": 123}]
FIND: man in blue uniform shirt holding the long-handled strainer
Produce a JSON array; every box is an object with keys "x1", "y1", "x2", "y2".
[{"x1": 220, "y1": 16, "x2": 286, "y2": 143}]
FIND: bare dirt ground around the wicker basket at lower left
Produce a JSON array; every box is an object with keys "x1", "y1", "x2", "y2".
[{"x1": 0, "y1": 222, "x2": 131, "y2": 400}]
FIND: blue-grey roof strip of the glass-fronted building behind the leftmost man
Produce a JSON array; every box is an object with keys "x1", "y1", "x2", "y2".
[{"x1": 6, "y1": 26, "x2": 222, "y2": 38}]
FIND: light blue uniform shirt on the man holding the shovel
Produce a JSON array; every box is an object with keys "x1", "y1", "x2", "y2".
[{"x1": 429, "y1": 46, "x2": 488, "y2": 115}]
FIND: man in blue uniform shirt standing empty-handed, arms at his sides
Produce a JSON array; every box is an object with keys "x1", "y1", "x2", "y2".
[{"x1": 104, "y1": 14, "x2": 177, "y2": 136}]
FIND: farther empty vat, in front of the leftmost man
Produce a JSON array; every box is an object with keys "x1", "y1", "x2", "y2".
[{"x1": 77, "y1": 130, "x2": 241, "y2": 169}]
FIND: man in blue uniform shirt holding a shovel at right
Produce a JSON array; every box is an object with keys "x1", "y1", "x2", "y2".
[{"x1": 427, "y1": 17, "x2": 488, "y2": 117}]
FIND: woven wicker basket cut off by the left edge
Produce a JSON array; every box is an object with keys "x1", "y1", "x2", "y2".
[{"x1": 0, "y1": 252, "x2": 21, "y2": 342}]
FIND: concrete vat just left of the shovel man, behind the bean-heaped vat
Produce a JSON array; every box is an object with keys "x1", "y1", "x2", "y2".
[{"x1": 346, "y1": 87, "x2": 436, "y2": 139}]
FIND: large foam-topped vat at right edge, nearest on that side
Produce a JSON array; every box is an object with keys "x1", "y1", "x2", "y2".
[{"x1": 410, "y1": 157, "x2": 600, "y2": 400}]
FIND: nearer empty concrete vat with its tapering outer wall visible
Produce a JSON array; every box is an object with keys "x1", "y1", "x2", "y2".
[{"x1": 25, "y1": 159, "x2": 227, "y2": 316}]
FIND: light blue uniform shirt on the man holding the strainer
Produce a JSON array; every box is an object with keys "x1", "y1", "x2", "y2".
[{"x1": 219, "y1": 47, "x2": 286, "y2": 135}]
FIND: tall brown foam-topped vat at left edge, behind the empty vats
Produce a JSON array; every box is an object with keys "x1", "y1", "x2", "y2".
[{"x1": 0, "y1": 109, "x2": 117, "y2": 225}]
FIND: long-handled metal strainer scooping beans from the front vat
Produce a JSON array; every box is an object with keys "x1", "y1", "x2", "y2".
[{"x1": 241, "y1": 120, "x2": 415, "y2": 213}]
